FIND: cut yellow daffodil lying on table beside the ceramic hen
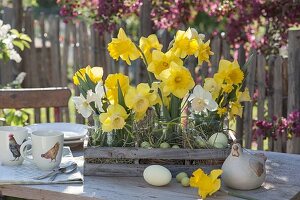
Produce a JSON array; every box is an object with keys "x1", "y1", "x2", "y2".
[{"x1": 190, "y1": 169, "x2": 223, "y2": 199}]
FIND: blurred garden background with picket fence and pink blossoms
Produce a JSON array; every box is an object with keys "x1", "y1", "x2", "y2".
[{"x1": 0, "y1": 0, "x2": 300, "y2": 153}]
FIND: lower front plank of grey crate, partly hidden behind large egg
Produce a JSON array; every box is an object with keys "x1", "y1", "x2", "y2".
[{"x1": 84, "y1": 163, "x2": 221, "y2": 177}]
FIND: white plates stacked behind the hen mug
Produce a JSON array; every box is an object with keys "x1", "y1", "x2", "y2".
[{"x1": 27, "y1": 122, "x2": 88, "y2": 140}]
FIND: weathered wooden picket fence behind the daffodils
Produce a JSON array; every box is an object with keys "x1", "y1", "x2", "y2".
[{"x1": 0, "y1": 8, "x2": 300, "y2": 153}]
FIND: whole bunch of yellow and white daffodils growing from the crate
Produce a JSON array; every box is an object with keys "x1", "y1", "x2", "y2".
[{"x1": 73, "y1": 28, "x2": 250, "y2": 147}]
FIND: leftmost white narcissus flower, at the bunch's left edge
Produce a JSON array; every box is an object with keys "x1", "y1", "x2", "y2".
[{"x1": 72, "y1": 90, "x2": 93, "y2": 118}]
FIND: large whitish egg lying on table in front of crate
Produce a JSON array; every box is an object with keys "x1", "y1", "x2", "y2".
[{"x1": 143, "y1": 165, "x2": 172, "y2": 186}]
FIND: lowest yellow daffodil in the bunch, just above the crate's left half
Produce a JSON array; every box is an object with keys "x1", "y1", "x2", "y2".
[{"x1": 99, "y1": 104, "x2": 128, "y2": 132}]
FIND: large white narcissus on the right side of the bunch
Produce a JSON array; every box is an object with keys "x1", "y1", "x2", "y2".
[{"x1": 189, "y1": 85, "x2": 218, "y2": 112}]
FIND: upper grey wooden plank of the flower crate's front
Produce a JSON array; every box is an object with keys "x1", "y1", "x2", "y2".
[{"x1": 84, "y1": 147, "x2": 229, "y2": 160}]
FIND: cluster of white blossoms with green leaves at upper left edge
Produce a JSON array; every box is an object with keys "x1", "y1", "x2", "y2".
[{"x1": 0, "y1": 20, "x2": 31, "y2": 63}]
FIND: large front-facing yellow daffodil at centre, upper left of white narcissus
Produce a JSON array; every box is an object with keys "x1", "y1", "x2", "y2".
[{"x1": 159, "y1": 62, "x2": 195, "y2": 99}]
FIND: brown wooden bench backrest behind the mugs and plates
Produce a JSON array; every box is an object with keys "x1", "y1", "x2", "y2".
[{"x1": 0, "y1": 87, "x2": 71, "y2": 122}]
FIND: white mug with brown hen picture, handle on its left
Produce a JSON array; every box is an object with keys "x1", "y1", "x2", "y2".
[{"x1": 20, "y1": 130, "x2": 64, "y2": 170}]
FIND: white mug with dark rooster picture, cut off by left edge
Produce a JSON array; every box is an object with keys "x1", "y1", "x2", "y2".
[{"x1": 0, "y1": 126, "x2": 28, "y2": 165}]
